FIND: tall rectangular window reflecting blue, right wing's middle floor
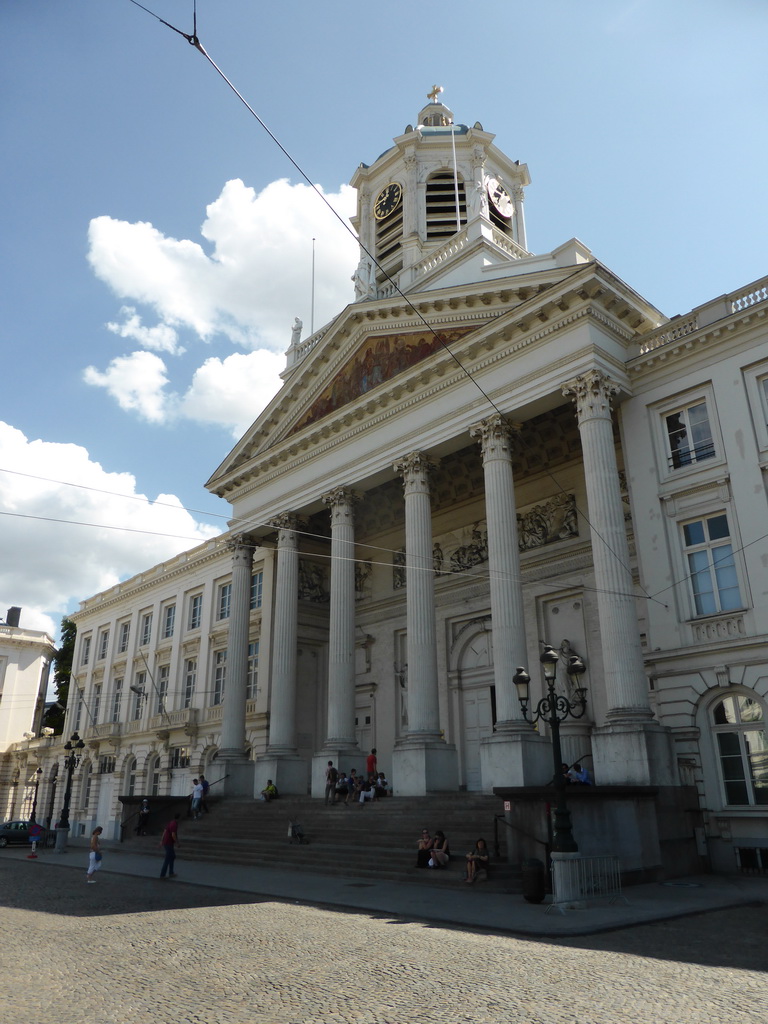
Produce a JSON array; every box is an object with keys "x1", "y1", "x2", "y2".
[{"x1": 683, "y1": 514, "x2": 741, "y2": 615}]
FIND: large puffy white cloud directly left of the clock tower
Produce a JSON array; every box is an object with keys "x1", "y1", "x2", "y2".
[{"x1": 88, "y1": 179, "x2": 357, "y2": 352}]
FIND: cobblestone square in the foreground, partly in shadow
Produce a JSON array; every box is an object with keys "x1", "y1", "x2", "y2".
[{"x1": 0, "y1": 859, "x2": 768, "y2": 1024}]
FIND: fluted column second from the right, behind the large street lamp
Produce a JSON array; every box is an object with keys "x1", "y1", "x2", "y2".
[{"x1": 469, "y1": 414, "x2": 530, "y2": 732}]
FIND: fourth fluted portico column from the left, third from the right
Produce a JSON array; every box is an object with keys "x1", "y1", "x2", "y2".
[{"x1": 394, "y1": 452, "x2": 440, "y2": 738}]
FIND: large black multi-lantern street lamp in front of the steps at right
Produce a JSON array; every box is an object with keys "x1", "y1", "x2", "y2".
[{"x1": 513, "y1": 644, "x2": 587, "y2": 853}]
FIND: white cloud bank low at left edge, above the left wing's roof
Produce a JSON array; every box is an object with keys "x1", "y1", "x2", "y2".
[{"x1": 0, "y1": 421, "x2": 221, "y2": 634}]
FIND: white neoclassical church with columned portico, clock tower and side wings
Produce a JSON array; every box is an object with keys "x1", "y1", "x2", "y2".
[{"x1": 0, "y1": 101, "x2": 768, "y2": 870}]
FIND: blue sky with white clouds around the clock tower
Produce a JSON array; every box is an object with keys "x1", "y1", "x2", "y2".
[{"x1": 0, "y1": 0, "x2": 768, "y2": 636}]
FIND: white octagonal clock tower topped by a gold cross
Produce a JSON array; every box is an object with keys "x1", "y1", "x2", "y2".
[{"x1": 351, "y1": 86, "x2": 530, "y2": 302}]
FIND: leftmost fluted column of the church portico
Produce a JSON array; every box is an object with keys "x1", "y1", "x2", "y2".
[{"x1": 219, "y1": 536, "x2": 254, "y2": 759}]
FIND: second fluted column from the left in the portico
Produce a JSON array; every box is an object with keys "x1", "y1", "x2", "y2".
[{"x1": 268, "y1": 513, "x2": 299, "y2": 754}]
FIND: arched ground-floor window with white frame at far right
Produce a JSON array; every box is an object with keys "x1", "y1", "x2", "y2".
[{"x1": 711, "y1": 693, "x2": 768, "y2": 806}]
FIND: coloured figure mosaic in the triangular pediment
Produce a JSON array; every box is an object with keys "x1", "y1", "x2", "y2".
[{"x1": 291, "y1": 327, "x2": 475, "y2": 434}]
